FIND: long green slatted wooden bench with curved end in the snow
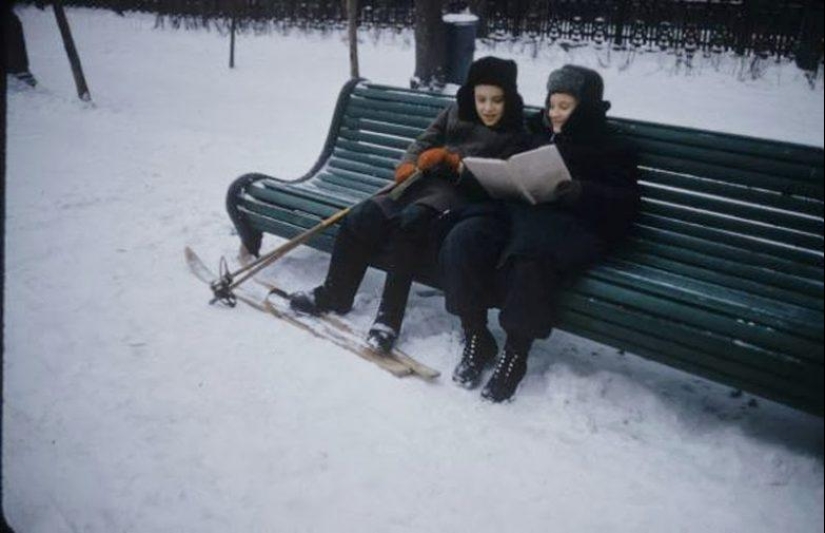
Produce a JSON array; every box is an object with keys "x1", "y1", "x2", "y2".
[{"x1": 227, "y1": 80, "x2": 823, "y2": 416}]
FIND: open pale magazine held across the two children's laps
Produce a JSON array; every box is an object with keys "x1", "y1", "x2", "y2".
[{"x1": 463, "y1": 144, "x2": 571, "y2": 205}]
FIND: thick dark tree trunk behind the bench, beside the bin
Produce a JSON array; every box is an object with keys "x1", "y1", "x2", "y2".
[{"x1": 410, "y1": 0, "x2": 447, "y2": 89}]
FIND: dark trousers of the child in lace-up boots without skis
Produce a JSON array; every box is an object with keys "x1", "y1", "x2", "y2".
[{"x1": 439, "y1": 216, "x2": 562, "y2": 341}]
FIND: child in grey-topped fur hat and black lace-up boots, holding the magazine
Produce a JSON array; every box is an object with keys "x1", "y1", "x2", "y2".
[{"x1": 439, "y1": 65, "x2": 639, "y2": 402}]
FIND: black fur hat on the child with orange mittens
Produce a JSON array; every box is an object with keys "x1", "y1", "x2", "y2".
[{"x1": 456, "y1": 56, "x2": 524, "y2": 129}]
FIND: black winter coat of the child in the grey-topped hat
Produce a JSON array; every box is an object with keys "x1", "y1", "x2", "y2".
[{"x1": 492, "y1": 102, "x2": 639, "y2": 273}]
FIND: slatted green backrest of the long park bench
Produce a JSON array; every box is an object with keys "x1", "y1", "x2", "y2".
[{"x1": 326, "y1": 84, "x2": 825, "y2": 296}]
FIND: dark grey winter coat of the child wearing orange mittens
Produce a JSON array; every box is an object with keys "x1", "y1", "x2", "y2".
[{"x1": 376, "y1": 102, "x2": 524, "y2": 215}]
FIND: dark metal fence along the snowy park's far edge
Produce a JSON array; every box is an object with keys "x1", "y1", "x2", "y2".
[{"x1": 22, "y1": 0, "x2": 823, "y2": 69}]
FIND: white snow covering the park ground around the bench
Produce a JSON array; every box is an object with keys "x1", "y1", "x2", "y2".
[{"x1": 3, "y1": 8, "x2": 823, "y2": 533}]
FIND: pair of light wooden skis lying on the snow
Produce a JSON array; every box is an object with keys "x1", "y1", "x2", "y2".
[{"x1": 185, "y1": 247, "x2": 440, "y2": 380}]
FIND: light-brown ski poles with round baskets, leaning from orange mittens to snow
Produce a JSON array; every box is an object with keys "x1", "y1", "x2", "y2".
[{"x1": 211, "y1": 170, "x2": 422, "y2": 302}]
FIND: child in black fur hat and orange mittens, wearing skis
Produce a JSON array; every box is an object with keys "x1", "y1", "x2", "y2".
[{"x1": 290, "y1": 57, "x2": 524, "y2": 351}]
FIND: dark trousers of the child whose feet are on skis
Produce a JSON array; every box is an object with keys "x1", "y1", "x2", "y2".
[{"x1": 320, "y1": 200, "x2": 438, "y2": 331}]
